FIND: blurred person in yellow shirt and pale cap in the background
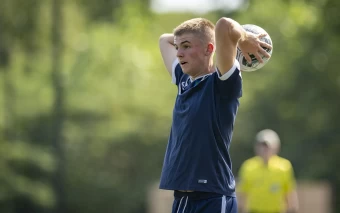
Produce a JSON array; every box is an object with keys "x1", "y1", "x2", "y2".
[{"x1": 237, "y1": 129, "x2": 298, "y2": 213}]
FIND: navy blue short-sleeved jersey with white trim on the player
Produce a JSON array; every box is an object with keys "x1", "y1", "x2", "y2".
[{"x1": 160, "y1": 61, "x2": 242, "y2": 196}]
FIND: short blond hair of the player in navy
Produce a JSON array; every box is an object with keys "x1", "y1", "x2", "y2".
[{"x1": 173, "y1": 18, "x2": 215, "y2": 44}]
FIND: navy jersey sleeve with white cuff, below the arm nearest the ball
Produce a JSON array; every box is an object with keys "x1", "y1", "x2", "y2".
[{"x1": 216, "y1": 59, "x2": 242, "y2": 98}]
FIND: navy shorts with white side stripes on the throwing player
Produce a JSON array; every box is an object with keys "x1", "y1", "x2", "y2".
[{"x1": 172, "y1": 191, "x2": 237, "y2": 213}]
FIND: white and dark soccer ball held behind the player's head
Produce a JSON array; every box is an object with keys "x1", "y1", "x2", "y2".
[{"x1": 236, "y1": 24, "x2": 273, "y2": 72}]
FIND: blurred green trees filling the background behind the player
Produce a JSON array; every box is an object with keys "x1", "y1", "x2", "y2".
[{"x1": 0, "y1": 0, "x2": 340, "y2": 213}]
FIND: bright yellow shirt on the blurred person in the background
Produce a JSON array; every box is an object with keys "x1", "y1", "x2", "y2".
[{"x1": 236, "y1": 156, "x2": 296, "y2": 212}]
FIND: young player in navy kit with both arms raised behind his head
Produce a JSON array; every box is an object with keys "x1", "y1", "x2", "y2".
[{"x1": 159, "y1": 18, "x2": 271, "y2": 213}]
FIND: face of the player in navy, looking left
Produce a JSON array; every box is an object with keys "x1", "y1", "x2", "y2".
[{"x1": 174, "y1": 33, "x2": 209, "y2": 77}]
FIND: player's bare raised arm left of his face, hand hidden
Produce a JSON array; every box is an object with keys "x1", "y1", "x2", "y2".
[{"x1": 159, "y1": 34, "x2": 177, "y2": 76}]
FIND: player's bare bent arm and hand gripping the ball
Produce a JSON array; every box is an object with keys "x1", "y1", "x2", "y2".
[{"x1": 215, "y1": 18, "x2": 272, "y2": 75}]
